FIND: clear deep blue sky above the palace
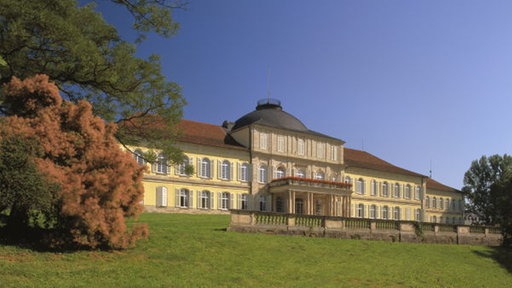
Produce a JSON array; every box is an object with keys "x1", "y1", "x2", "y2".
[{"x1": 98, "y1": 0, "x2": 512, "y2": 189}]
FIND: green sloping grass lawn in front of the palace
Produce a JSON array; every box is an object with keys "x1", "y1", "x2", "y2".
[{"x1": 0, "y1": 214, "x2": 512, "y2": 287}]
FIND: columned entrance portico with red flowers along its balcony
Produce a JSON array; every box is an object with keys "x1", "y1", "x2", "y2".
[{"x1": 269, "y1": 177, "x2": 352, "y2": 217}]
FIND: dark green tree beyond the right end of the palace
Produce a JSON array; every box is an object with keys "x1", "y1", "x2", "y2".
[{"x1": 462, "y1": 154, "x2": 512, "y2": 245}]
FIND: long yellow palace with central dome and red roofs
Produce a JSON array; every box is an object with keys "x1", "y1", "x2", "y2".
[{"x1": 132, "y1": 99, "x2": 464, "y2": 224}]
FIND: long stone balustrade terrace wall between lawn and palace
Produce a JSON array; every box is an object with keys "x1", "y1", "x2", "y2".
[{"x1": 228, "y1": 210, "x2": 503, "y2": 246}]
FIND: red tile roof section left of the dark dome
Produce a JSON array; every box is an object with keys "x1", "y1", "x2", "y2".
[{"x1": 178, "y1": 120, "x2": 246, "y2": 150}]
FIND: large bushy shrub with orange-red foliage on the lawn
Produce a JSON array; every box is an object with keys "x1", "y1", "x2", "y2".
[{"x1": 0, "y1": 75, "x2": 147, "y2": 248}]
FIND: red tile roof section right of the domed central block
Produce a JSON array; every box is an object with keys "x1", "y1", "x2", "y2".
[{"x1": 344, "y1": 148, "x2": 427, "y2": 177}]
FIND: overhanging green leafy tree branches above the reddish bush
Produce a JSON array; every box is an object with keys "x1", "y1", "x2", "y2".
[{"x1": 0, "y1": 0, "x2": 185, "y2": 161}]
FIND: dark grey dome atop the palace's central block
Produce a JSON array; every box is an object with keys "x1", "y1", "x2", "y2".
[{"x1": 231, "y1": 99, "x2": 309, "y2": 132}]
